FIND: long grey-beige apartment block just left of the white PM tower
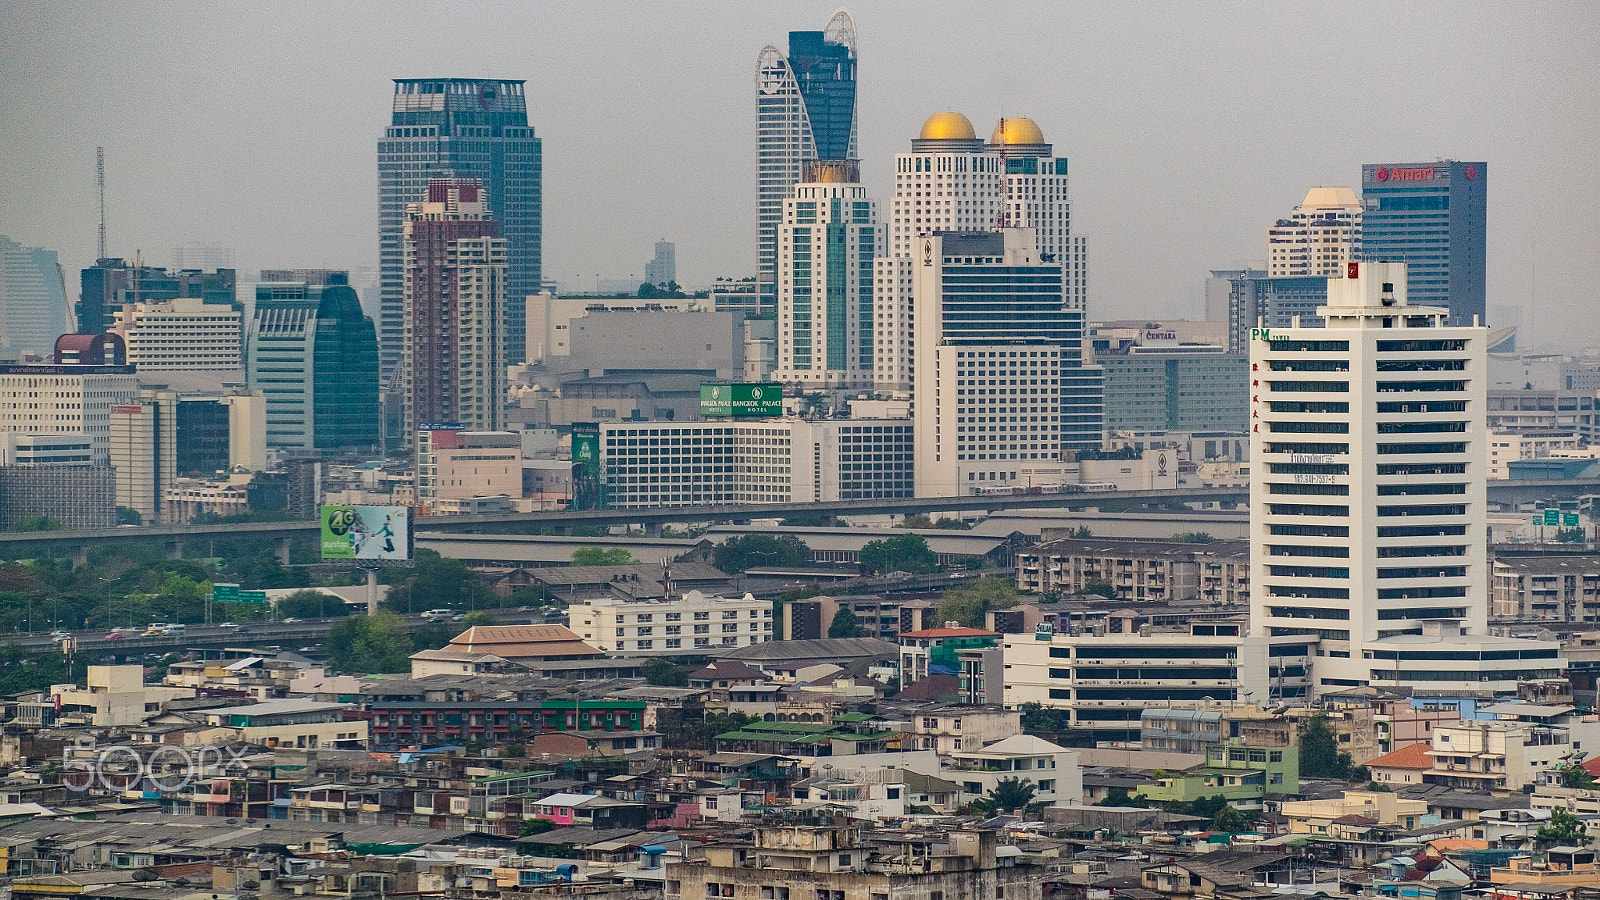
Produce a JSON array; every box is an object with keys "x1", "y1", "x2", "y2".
[{"x1": 1016, "y1": 538, "x2": 1250, "y2": 605}]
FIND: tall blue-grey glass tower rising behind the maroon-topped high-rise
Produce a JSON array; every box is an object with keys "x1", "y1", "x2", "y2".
[{"x1": 378, "y1": 78, "x2": 540, "y2": 374}]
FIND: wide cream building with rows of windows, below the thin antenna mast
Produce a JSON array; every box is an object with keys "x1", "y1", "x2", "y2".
[{"x1": 112, "y1": 298, "x2": 245, "y2": 372}]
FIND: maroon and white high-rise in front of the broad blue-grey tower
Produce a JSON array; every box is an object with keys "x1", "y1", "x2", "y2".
[{"x1": 400, "y1": 178, "x2": 509, "y2": 434}]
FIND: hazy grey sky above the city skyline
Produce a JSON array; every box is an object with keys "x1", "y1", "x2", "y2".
[{"x1": 0, "y1": 0, "x2": 1600, "y2": 344}]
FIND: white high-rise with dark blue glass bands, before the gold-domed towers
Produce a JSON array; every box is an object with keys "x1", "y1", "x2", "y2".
[{"x1": 912, "y1": 227, "x2": 1101, "y2": 496}]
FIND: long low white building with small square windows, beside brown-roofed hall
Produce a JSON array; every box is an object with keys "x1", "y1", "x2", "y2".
[{"x1": 566, "y1": 591, "x2": 773, "y2": 657}]
